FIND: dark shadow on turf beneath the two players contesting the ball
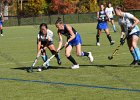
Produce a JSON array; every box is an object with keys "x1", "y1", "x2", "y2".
[{"x1": 11, "y1": 66, "x2": 70, "y2": 70}]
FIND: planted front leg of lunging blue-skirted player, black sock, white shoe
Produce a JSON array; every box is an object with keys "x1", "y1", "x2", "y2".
[{"x1": 65, "y1": 45, "x2": 79, "y2": 69}]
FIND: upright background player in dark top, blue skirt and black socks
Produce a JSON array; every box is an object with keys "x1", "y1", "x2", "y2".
[{"x1": 96, "y1": 4, "x2": 114, "y2": 46}]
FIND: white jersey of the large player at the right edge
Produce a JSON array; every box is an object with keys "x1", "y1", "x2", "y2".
[{"x1": 118, "y1": 13, "x2": 140, "y2": 35}]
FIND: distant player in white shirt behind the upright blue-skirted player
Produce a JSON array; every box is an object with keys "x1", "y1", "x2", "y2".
[{"x1": 105, "y1": 2, "x2": 116, "y2": 32}]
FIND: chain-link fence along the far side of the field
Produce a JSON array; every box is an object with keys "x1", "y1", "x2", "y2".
[{"x1": 4, "y1": 10, "x2": 140, "y2": 26}]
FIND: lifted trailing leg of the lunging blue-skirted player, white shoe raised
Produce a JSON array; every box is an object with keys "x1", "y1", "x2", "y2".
[{"x1": 76, "y1": 44, "x2": 94, "y2": 62}]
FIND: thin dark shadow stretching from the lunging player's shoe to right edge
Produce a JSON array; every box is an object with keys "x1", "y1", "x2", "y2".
[{"x1": 80, "y1": 64, "x2": 140, "y2": 68}]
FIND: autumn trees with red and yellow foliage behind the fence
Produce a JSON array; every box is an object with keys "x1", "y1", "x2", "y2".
[{"x1": 1, "y1": 0, "x2": 139, "y2": 16}]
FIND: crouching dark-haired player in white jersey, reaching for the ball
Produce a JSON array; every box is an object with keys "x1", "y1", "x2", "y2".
[{"x1": 37, "y1": 23, "x2": 61, "y2": 68}]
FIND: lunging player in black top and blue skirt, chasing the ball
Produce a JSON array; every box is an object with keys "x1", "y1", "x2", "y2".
[{"x1": 55, "y1": 18, "x2": 94, "y2": 69}]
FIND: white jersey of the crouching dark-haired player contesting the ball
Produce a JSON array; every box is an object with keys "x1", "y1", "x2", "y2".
[{"x1": 37, "y1": 29, "x2": 53, "y2": 42}]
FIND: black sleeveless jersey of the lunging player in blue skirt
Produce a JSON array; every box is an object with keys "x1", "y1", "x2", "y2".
[{"x1": 58, "y1": 25, "x2": 77, "y2": 39}]
